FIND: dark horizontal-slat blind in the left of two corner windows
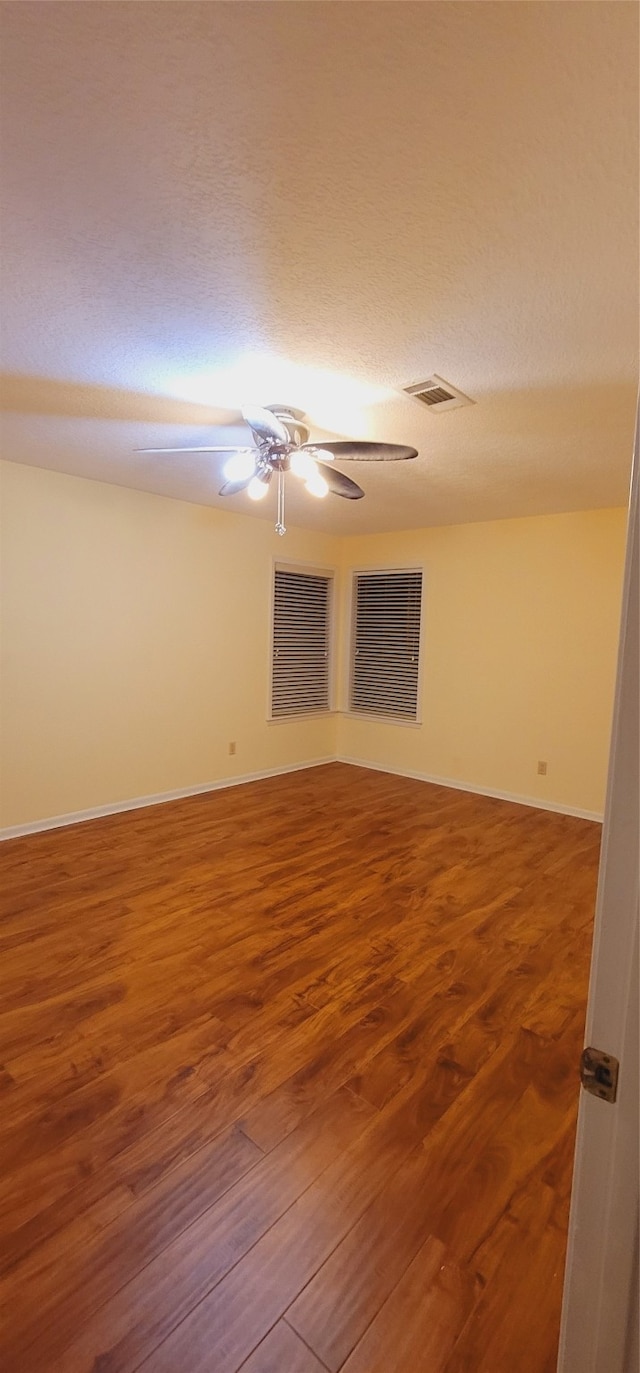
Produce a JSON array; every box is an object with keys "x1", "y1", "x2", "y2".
[{"x1": 271, "y1": 567, "x2": 332, "y2": 717}]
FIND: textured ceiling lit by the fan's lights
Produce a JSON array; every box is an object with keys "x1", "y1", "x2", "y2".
[{"x1": 0, "y1": 0, "x2": 639, "y2": 533}]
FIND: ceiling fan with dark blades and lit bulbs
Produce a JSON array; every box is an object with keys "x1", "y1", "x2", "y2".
[{"x1": 136, "y1": 405, "x2": 418, "y2": 534}]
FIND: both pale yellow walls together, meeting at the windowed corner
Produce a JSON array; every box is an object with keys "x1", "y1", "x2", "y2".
[{"x1": 0, "y1": 463, "x2": 625, "y2": 827}]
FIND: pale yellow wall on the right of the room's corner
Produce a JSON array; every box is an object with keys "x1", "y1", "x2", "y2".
[{"x1": 338, "y1": 509, "x2": 626, "y2": 813}]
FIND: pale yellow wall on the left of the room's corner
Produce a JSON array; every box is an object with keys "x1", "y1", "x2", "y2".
[{"x1": 0, "y1": 463, "x2": 339, "y2": 825}]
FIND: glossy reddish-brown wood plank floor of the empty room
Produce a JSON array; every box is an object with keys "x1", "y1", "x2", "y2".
[{"x1": 0, "y1": 763, "x2": 600, "y2": 1373}]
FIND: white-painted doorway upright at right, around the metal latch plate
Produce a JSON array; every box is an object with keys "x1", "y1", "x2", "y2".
[{"x1": 558, "y1": 416, "x2": 640, "y2": 1373}]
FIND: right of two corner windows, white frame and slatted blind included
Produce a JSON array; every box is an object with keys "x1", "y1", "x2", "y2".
[{"x1": 349, "y1": 571, "x2": 422, "y2": 721}]
